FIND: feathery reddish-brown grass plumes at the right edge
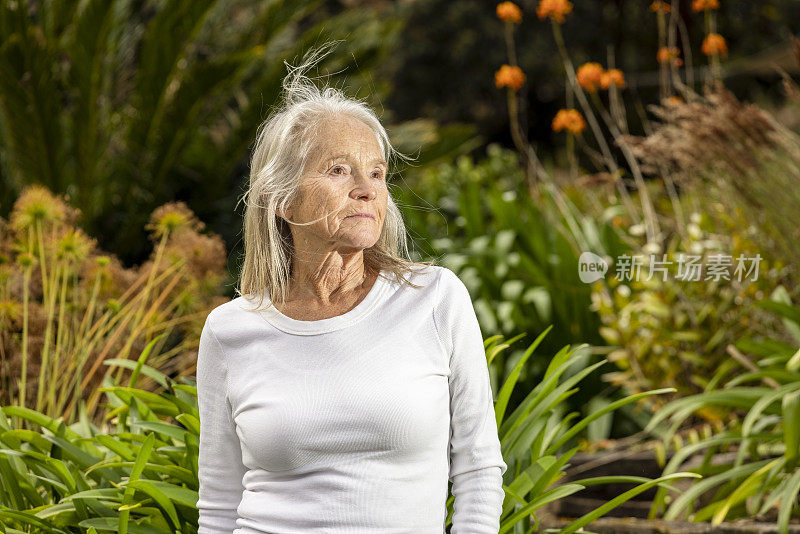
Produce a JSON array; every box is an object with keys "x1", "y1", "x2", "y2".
[{"x1": 625, "y1": 82, "x2": 800, "y2": 272}]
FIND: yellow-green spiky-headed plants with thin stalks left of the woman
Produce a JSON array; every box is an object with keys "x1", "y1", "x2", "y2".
[{"x1": 0, "y1": 186, "x2": 226, "y2": 430}]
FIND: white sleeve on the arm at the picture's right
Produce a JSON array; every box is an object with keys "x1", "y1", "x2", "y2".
[{"x1": 434, "y1": 268, "x2": 507, "y2": 534}]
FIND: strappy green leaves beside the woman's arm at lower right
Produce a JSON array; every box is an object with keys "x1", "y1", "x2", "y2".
[{"x1": 462, "y1": 327, "x2": 698, "y2": 533}]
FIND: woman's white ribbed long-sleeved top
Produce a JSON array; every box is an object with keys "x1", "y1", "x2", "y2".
[{"x1": 197, "y1": 265, "x2": 507, "y2": 534}]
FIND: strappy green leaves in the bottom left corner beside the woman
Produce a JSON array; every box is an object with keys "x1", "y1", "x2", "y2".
[{"x1": 0, "y1": 343, "x2": 200, "y2": 534}]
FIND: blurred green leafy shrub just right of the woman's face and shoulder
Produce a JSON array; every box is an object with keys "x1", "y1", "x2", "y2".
[{"x1": 400, "y1": 144, "x2": 639, "y2": 438}]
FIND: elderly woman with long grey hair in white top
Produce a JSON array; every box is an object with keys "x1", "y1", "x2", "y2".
[{"x1": 197, "y1": 46, "x2": 507, "y2": 534}]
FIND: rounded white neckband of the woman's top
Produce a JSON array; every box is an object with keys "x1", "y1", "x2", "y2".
[{"x1": 242, "y1": 270, "x2": 391, "y2": 336}]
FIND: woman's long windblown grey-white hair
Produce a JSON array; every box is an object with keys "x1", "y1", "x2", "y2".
[{"x1": 235, "y1": 41, "x2": 432, "y2": 309}]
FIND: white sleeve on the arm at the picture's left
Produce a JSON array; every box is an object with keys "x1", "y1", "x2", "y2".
[{"x1": 197, "y1": 317, "x2": 247, "y2": 534}]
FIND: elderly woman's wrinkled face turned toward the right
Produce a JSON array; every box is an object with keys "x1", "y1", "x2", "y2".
[{"x1": 286, "y1": 116, "x2": 389, "y2": 255}]
